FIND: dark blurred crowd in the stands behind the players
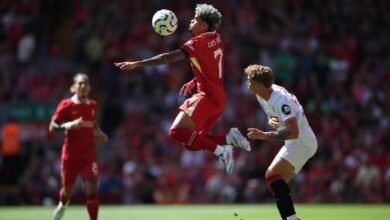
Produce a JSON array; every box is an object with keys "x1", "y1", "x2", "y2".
[{"x1": 0, "y1": 0, "x2": 390, "y2": 205}]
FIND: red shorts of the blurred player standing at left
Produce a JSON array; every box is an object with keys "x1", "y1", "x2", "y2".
[{"x1": 61, "y1": 160, "x2": 99, "y2": 186}]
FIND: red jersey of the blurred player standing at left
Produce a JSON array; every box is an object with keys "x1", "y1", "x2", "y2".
[{"x1": 51, "y1": 96, "x2": 96, "y2": 160}]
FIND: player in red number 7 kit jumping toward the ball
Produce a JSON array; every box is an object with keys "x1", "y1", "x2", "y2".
[{"x1": 115, "y1": 4, "x2": 250, "y2": 175}]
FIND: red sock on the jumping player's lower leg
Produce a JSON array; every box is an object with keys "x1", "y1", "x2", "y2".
[{"x1": 169, "y1": 128, "x2": 218, "y2": 153}]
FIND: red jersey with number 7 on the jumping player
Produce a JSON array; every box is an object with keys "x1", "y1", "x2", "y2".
[{"x1": 181, "y1": 32, "x2": 226, "y2": 103}]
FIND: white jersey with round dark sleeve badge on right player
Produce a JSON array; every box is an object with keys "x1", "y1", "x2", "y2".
[{"x1": 256, "y1": 84, "x2": 315, "y2": 143}]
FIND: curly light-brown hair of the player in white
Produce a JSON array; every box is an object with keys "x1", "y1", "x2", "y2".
[{"x1": 244, "y1": 64, "x2": 274, "y2": 88}]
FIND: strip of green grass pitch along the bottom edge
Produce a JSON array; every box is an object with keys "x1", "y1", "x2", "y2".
[{"x1": 0, "y1": 204, "x2": 390, "y2": 220}]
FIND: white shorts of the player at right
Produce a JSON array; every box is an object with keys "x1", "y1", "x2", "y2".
[{"x1": 276, "y1": 137, "x2": 318, "y2": 174}]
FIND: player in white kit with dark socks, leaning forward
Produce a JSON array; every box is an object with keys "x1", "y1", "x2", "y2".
[{"x1": 244, "y1": 65, "x2": 317, "y2": 220}]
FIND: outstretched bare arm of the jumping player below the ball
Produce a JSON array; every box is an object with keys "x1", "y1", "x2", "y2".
[{"x1": 114, "y1": 49, "x2": 186, "y2": 70}]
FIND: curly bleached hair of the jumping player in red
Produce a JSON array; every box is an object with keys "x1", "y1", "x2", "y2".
[{"x1": 195, "y1": 4, "x2": 222, "y2": 31}]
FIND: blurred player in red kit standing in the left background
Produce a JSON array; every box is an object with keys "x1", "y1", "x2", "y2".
[{"x1": 49, "y1": 73, "x2": 108, "y2": 220}]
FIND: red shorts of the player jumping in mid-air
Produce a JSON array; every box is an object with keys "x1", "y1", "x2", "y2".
[{"x1": 179, "y1": 94, "x2": 226, "y2": 135}]
